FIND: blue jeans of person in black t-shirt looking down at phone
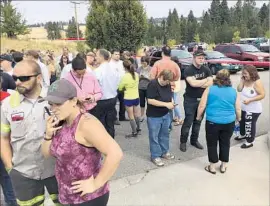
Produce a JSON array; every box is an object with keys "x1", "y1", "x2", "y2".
[{"x1": 147, "y1": 113, "x2": 171, "y2": 159}]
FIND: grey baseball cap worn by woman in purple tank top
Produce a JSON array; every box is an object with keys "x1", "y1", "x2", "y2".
[{"x1": 41, "y1": 79, "x2": 77, "y2": 104}]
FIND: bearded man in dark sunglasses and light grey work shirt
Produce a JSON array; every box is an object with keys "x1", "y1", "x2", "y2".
[{"x1": 1, "y1": 60, "x2": 59, "y2": 206}]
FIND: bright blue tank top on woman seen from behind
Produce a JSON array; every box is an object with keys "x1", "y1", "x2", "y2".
[{"x1": 206, "y1": 85, "x2": 237, "y2": 124}]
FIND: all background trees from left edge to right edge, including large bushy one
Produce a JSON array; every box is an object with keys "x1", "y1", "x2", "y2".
[{"x1": 1, "y1": 0, "x2": 270, "y2": 51}]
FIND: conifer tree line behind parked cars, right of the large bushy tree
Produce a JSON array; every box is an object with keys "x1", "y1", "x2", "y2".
[{"x1": 145, "y1": 0, "x2": 270, "y2": 45}]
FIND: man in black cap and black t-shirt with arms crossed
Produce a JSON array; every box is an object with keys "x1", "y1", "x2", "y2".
[{"x1": 180, "y1": 50, "x2": 213, "y2": 152}]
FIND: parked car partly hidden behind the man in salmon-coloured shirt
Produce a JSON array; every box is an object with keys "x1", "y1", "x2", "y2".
[{"x1": 150, "y1": 49, "x2": 193, "y2": 79}]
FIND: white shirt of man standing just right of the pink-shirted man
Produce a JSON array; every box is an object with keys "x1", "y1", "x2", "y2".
[{"x1": 94, "y1": 62, "x2": 120, "y2": 100}]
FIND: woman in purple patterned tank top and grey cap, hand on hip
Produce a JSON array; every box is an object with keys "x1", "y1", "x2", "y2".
[{"x1": 42, "y1": 79, "x2": 123, "y2": 206}]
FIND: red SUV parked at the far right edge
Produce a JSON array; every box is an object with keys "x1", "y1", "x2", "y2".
[{"x1": 214, "y1": 44, "x2": 270, "y2": 69}]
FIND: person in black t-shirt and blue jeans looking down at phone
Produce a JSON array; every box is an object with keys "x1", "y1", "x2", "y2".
[{"x1": 146, "y1": 70, "x2": 175, "y2": 167}]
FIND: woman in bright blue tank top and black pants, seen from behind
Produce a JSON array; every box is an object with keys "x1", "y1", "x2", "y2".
[{"x1": 196, "y1": 69, "x2": 241, "y2": 174}]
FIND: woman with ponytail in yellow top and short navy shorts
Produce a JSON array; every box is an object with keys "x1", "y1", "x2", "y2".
[{"x1": 118, "y1": 60, "x2": 141, "y2": 138}]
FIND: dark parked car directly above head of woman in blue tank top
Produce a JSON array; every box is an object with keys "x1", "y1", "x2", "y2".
[{"x1": 204, "y1": 51, "x2": 243, "y2": 74}]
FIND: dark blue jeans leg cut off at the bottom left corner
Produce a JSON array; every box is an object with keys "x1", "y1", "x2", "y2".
[{"x1": 0, "y1": 159, "x2": 17, "y2": 206}]
